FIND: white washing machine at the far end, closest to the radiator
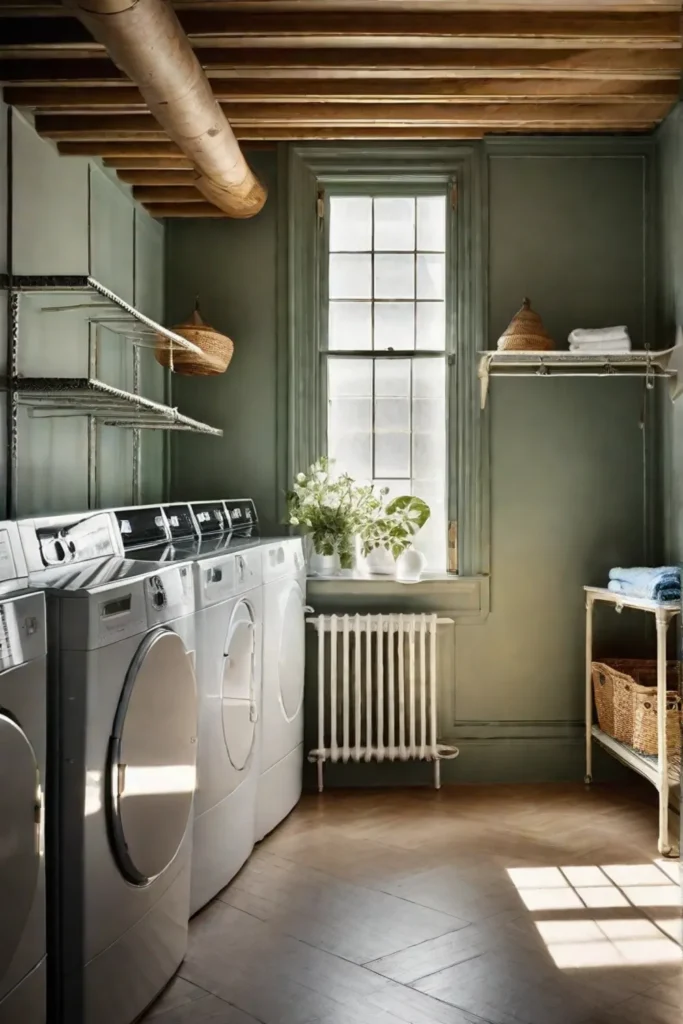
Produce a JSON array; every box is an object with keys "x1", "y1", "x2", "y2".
[{"x1": 256, "y1": 538, "x2": 306, "y2": 841}]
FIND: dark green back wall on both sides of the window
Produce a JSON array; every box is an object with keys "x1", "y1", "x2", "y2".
[{"x1": 167, "y1": 139, "x2": 652, "y2": 782}]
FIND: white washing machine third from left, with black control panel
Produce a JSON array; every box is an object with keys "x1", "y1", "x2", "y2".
[{"x1": 115, "y1": 500, "x2": 262, "y2": 913}]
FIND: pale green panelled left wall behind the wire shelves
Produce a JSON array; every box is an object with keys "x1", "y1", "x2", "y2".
[{"x1": 0, "y1": 108, "x2": 167, "y2": 517}]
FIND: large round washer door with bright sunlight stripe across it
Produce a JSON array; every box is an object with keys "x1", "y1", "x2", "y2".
[{"x1": 108, "y1": 629, "x2": 197, "y2": 886}]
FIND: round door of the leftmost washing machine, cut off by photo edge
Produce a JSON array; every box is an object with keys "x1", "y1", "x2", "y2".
[{"x1": 0, "y1": 711, "x2": 40, "y2": 989}]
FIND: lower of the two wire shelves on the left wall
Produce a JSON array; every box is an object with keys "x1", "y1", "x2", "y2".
[{"x1": 12, "y1": 377, "x2": 223, "y2": 437}]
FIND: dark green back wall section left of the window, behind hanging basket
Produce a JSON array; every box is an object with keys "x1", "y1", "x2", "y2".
[{"x1": 166, "y1": 153, "x2": 279, "y2": 529}]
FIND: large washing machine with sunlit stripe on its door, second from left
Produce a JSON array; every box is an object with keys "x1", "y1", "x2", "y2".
[{"x1": 19, "y1": 513, "x2": 197, "y2": 1024}]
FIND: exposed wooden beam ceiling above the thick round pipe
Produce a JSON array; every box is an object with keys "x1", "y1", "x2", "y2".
[{"x1": 0, "y1": 0, "x2": 683, "y2": 217}]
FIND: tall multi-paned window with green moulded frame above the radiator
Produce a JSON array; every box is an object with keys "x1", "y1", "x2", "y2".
[{"x1": 286, "y1": 142, "x2": 489, "y2": 593}]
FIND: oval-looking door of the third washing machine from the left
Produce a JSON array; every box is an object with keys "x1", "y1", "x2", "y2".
[{"x1": 222, "y1": 601, "x2": 256, "y2": 771}]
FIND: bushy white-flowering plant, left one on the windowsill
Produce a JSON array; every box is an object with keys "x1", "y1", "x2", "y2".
[{"x1": 287, "y1": 458, "x2": 381, "y2": 575}]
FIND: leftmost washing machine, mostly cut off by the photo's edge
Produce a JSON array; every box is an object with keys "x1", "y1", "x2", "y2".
[{"x1": 0, "y1": 522, "x2": 47, "y2": 1024}]
